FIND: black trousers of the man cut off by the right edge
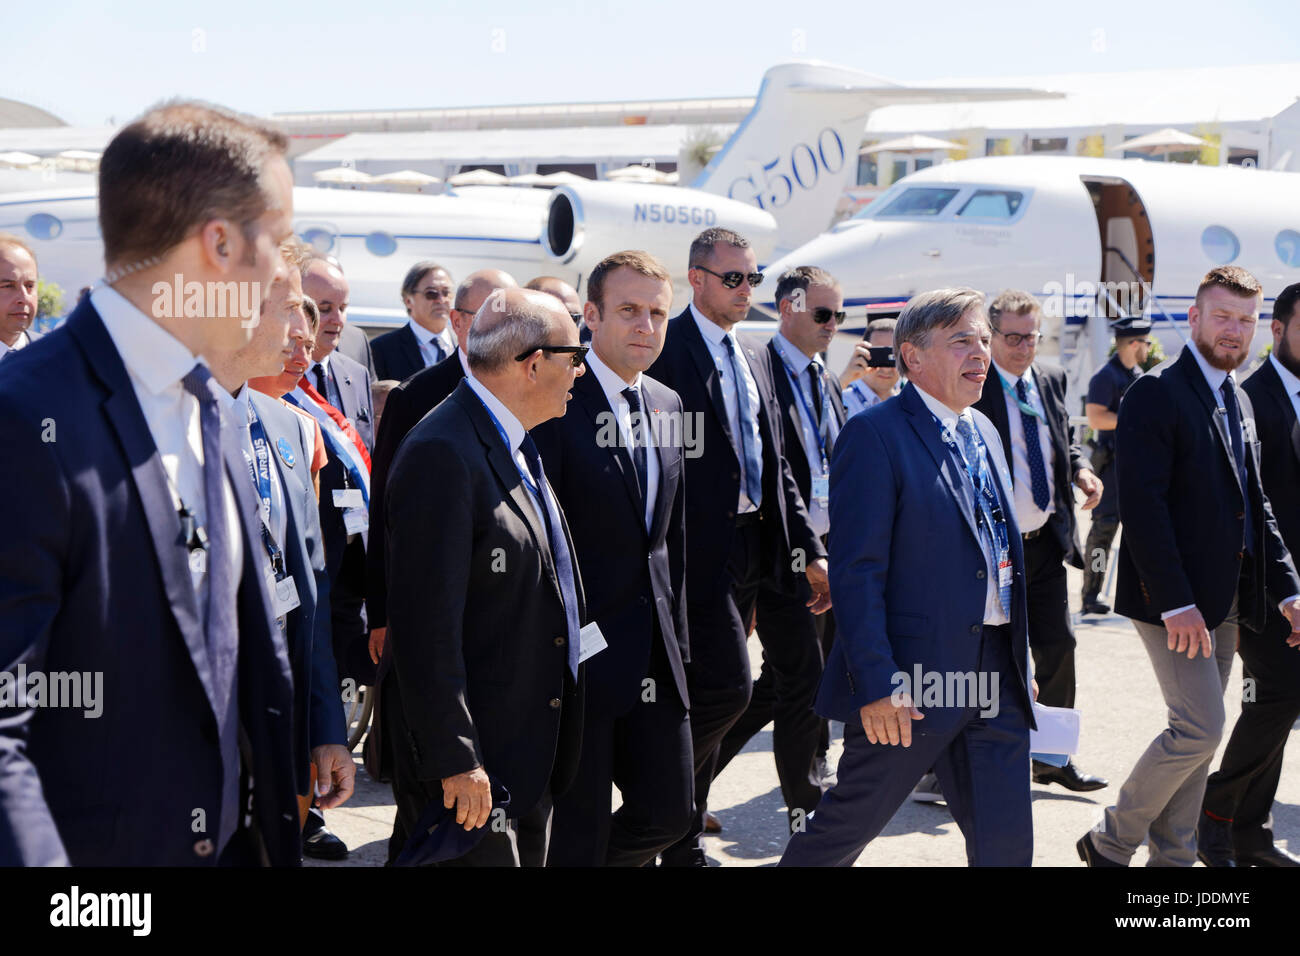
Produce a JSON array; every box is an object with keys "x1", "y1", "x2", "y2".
[{"x1": 1203, "y1": 606, "x2": 1300, "y2": 851}]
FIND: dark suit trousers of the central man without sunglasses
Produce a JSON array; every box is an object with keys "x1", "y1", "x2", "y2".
[{"x1": 546, "y1": 634, "x2": 696, "y2": 866}]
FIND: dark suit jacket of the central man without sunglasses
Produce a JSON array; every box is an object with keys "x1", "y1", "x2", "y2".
[{"x1": 532, "y1": 368, "x2": 690, "y2": 715}]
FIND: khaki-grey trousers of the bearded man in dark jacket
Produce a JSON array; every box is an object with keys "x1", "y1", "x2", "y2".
[{"x1": 1092, "y1": 601, "x2": 1238, "y2": 866}]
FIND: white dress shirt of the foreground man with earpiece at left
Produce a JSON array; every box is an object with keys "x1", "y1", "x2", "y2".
[{"x1": 90, "y1": 285, "x2": 243, "y2": 628}]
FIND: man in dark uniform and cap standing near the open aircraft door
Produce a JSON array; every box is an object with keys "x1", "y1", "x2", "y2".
[{"x1": 1083, "y1": 316, "x2": 1151, "y2": 614}]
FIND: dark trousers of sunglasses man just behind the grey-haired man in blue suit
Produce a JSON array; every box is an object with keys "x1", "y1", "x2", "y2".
[{"x1": 716, "y1": 587, "x2": 824, "y2": 825}]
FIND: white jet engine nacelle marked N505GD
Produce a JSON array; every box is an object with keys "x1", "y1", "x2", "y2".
[{"x1": 542, "y1": 182, "x2": 776, "y2": 282}]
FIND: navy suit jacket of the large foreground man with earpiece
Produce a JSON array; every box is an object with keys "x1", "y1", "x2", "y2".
[{"x1": 0, "y1": 299, "x2": 302, "y2": 866}]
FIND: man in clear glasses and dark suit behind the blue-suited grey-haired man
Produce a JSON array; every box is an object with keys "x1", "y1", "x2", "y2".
[{"x1": 975, "y1": 289, "x2": 1108, "y2": 791}]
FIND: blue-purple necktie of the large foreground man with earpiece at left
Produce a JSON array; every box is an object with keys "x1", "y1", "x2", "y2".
[{"x1": 181, "y1": 363, "x2": 239, "y2": 847}]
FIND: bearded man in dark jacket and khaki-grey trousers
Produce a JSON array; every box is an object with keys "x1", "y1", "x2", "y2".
[{"x1": 1078, "y1": 265, "x2": 1300, "y2": 866}]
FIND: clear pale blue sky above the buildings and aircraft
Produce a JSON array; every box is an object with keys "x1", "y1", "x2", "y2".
[{"x1": 10, "y1": 0, "x2": 1300, "y2": 125}]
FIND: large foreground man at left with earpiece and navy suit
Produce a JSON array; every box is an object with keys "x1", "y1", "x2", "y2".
[{"x1": 0, "y1": 103, "x2": 300, "y2": 866}]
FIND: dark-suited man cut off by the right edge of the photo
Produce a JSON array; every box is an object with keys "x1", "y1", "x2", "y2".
[{"x1": 1196, "y1": 282, "x2": 1300, "y2": 866}]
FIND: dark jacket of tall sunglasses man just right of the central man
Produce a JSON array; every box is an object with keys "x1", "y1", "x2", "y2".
[{"x1": 650, "y1": 307, "x2": 826, "y2": 601}]
